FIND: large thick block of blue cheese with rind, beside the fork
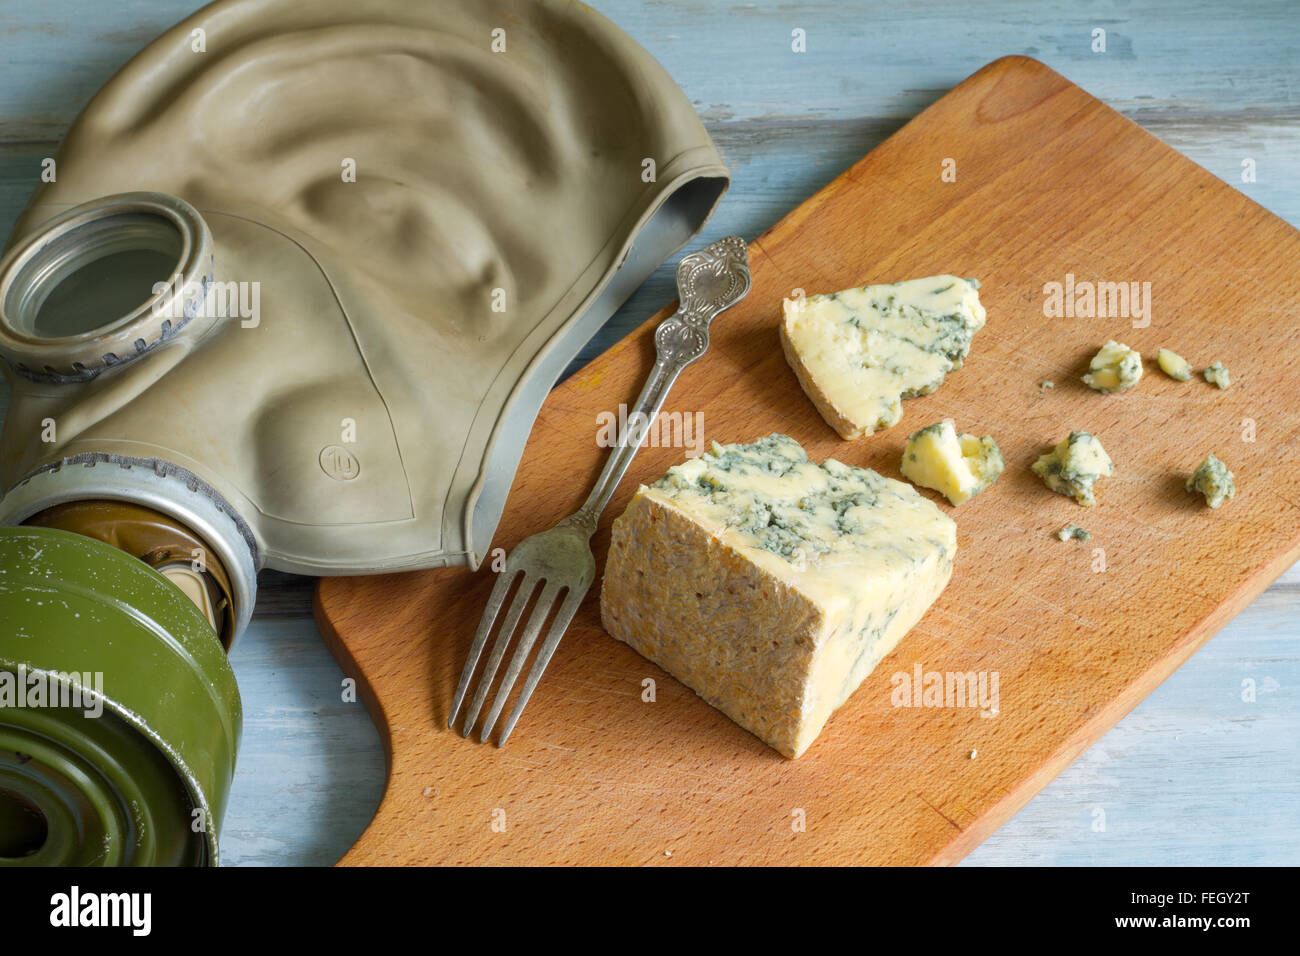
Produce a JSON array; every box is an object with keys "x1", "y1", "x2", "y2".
[{"x1": 601, "y1": 434, "x2": 957, "y2": 757}]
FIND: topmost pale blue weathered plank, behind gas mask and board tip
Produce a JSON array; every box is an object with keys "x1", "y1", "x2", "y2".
[{"x1": 0, "y1": 0, "x2": 1300, "y2": 142}]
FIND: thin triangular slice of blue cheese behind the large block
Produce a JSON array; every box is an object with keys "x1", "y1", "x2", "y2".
[{"x1": 781, "y1": 276, "x2": 985, "y2": 440}]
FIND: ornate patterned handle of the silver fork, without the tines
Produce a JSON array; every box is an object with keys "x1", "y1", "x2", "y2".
[{"x1": 568, "y1": 235, "x2": 750, "y2": 536}]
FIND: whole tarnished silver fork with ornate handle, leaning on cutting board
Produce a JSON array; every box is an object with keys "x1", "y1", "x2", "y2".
[{"x1": 447, "y1": 235, "x2": 750, "y2": 747}]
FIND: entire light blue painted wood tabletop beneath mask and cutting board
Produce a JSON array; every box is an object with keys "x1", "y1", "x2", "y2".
[{"x1": 0, "y1": 0, "x2": 1300, "y2": 865}]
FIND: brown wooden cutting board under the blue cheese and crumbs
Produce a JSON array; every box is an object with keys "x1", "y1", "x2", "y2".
[{"x1": 317, "y1": 57, "x2": 1300, "y2": 864}]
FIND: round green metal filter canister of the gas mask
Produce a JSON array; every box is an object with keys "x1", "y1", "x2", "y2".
[{"x1": 0, "y1": 528, "x2": 242, "y2": 866}]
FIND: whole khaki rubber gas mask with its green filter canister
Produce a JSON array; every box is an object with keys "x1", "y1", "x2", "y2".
[{"x1": 0, "y1": 0, "x2": 727, "y2": 864}]
